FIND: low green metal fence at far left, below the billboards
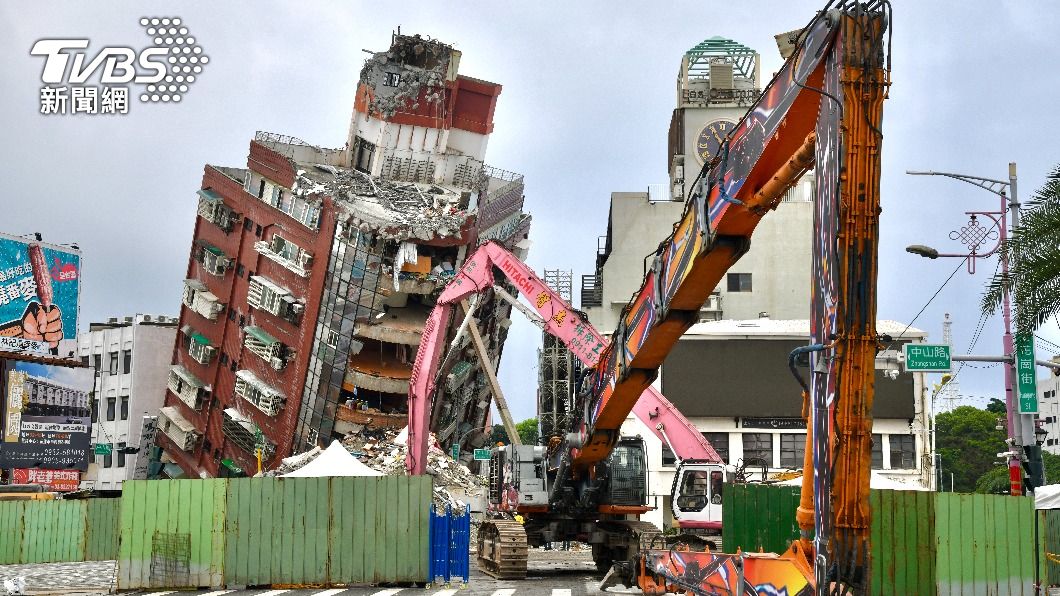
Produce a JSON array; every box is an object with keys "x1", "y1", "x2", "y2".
[{"x1": 0, "y1": 498, "x2": 120, "y2": 565}]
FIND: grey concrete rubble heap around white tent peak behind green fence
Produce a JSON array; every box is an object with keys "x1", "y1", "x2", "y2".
[{"x1": 264, "y1": 427, "x2": 487, "y2": 510}]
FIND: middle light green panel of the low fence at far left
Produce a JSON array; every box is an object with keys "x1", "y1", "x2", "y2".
[{"x1": 19, "y1": 501, "x2": 86, "y2": 563}]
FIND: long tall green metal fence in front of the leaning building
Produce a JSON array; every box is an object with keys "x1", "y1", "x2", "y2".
[{"x1": 118, "y1": 476, "x2": 430, "y2": 590}]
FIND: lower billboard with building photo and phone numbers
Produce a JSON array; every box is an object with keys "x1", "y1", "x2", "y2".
[{"x1": 0, "y1": 361, "x2": 95, "y2": 471}]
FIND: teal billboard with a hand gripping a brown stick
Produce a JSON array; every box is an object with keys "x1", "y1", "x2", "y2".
[{"x1": 0, "y1": 233, "x2": 81, "y2": 354}]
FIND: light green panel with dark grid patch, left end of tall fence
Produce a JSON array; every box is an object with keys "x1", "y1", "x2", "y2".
[{"x1": 118, "y1": 478, "x2": 228, "y2": 590}]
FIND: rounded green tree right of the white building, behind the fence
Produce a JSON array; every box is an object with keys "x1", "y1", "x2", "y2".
[{"x1": 935, "y1": 405, "x2": 1006, "y2": 492}]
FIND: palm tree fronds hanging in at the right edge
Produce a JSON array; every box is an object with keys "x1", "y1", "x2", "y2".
[{"x1": 982, "y1": 165, "x2": 1060, "y2": 333}]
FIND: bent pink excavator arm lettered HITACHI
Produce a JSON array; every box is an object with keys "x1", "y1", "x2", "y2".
[{"x1": 405, "y1": 242, "x2": 721, "y2": 475}]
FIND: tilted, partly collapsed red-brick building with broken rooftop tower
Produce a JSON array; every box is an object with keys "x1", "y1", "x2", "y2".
[{"x1": 158, "y1": 34, "x2": 530, "y2": 476}]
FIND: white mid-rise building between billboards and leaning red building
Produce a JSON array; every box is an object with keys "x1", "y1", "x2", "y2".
[{"x1": 77, "y1": 314, "x2": 177, "y2": 490}]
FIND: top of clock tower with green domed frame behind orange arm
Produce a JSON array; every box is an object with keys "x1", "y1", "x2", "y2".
[{"x1": 667, "y1": 36, "x2": 761, "y2": 200}]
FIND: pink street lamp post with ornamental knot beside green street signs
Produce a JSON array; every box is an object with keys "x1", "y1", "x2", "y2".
[{"x1": 906, "y1": 162, "x2": 1043, "y2": 494}]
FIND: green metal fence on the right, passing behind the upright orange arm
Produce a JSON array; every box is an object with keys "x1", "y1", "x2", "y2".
[{"x1": 722, "y1": 485, "x2": 1034, "y2": 595}]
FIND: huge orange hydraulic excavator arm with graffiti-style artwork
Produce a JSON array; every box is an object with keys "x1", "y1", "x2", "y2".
[{"x1": 580, "y1": 0, "x2": 890, "y2": 594}]
